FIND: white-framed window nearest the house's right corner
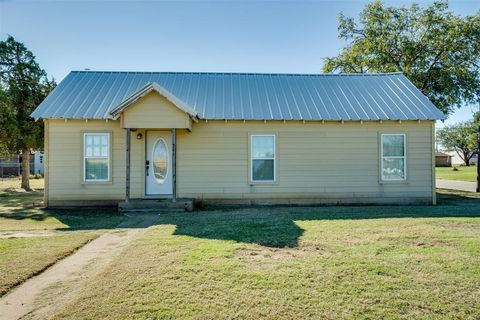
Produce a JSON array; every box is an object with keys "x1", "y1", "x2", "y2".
[{"x1": 381, "y1": 134, "x2": 407, "y2": 181}]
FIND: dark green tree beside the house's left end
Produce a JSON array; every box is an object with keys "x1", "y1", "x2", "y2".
[{"x1": 0, "y1": 36, "x2": 55, "y2": 190}]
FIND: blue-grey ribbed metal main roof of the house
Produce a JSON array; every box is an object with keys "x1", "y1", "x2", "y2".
[{"x1": 32, "y1": 71, "x2": 444, "y2": 121}]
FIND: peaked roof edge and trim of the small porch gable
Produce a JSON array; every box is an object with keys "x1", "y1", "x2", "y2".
[{"x1": 110, "y1": 82, "x2": 198, "y2": 122}]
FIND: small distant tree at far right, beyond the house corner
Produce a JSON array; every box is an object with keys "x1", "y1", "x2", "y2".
[{"x1": 437, "y1": 120, "x2": 477, "y2": 166}]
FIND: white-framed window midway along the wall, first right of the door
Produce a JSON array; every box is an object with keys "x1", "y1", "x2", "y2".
[{"x1": 250, "y1": 135, "x2": 275, "y2": 182}]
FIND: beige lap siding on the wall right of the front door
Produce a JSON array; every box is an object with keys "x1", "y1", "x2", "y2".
[{"x1": 177, "y1": 121, "x2": 432, "y2": 199}]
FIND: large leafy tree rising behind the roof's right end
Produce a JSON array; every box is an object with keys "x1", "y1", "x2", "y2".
[{"x1": 323, "y1": 1, "x2": 480, "y2": 115}]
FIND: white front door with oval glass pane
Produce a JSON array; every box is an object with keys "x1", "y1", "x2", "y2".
[{"x1": 145, "y1": 131, "x2": 172, "y2": 196}]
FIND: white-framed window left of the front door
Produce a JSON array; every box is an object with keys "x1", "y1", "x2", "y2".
[{"x1": 83, "y1": 133, "x2": 110, "y2": 181}]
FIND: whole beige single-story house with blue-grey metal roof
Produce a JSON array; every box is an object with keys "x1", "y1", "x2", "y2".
[{"x1": 32, "y1": 71, "x2": 444, "y2": 206}]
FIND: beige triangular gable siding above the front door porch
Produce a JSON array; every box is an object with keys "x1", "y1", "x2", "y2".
[{"x1": 122, "y1": 92, "x2": 192, "y2": 129}]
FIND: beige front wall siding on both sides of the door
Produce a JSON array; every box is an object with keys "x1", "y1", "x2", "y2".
[{"x1": 46, "y1": 117, "x2": 434, "y2": 205}]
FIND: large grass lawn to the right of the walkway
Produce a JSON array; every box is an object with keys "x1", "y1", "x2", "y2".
[{"x1": 51, "y1": 190, "x2": 480, "y2": 319}]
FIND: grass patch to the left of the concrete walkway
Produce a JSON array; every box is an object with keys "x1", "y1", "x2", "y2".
[{"x1": 0, "y1": 179, "x2": 124, "y2": 296}]
